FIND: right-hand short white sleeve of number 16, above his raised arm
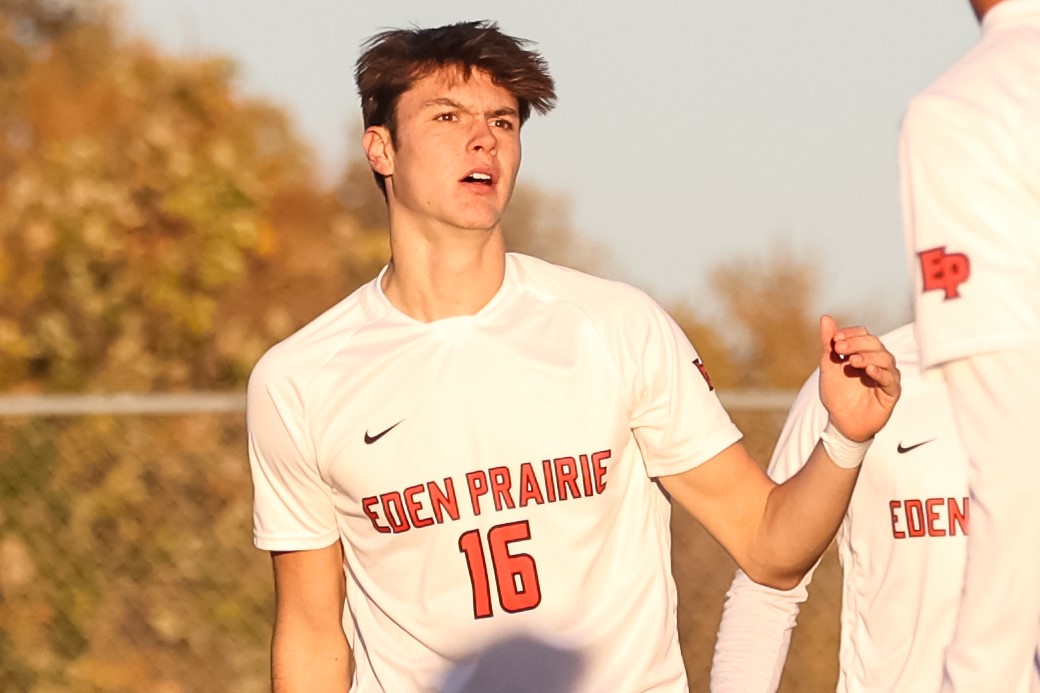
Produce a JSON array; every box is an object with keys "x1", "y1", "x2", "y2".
[{"x1": 626, "y1": 299, "x2": 740, "y2": 477}]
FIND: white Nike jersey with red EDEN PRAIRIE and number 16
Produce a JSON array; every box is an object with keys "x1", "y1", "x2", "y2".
[{"x1": 248, "y1": 254, "x2": 739, "y2": 693}]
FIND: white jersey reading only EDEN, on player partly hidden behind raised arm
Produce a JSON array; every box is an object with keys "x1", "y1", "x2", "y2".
[{"x1": 711, "y1": 325, "x2": 970, "y2": 693}]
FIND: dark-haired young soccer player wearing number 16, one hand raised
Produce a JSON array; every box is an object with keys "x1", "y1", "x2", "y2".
[{"x1": 249, "y1": 18, "x2": 900, "y2": 693}]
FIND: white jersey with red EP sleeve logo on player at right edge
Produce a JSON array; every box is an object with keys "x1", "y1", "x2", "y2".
[{"x1": 900, "y1": 0, "x2": 1040, "y2": 367}]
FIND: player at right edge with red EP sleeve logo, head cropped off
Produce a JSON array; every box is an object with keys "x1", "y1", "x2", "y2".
[{"x1": 900, "y1": 0, "x2": 1040, "y2": 693}]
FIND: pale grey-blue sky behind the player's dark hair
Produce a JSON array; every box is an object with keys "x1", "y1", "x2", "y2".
[{"x1": 123, "y1": 0, "x2": 979, "y2": 332}]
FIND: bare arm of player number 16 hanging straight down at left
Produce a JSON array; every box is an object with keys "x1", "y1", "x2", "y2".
[{"x1": 271, "y1": 541, "x2": 352, "y2": 693}]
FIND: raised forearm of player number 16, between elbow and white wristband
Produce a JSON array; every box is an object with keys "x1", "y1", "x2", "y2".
[{"x1": 749, "y1": 443, "x2": 859, "y2": 589}]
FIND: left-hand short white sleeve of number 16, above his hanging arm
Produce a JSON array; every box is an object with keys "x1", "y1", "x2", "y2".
[{"x1": 245, "y1": 353, "x2": 339, "y2": 551}]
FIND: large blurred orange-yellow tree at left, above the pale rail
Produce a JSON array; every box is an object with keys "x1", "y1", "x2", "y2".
[{"x1": 0, "y1": 0, "x2": 353, "y2": 390}]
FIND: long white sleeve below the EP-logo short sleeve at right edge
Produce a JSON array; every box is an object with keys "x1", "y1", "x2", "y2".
[{"x1": 942, "y1": 340, "x2": 1040, "y2": 691}]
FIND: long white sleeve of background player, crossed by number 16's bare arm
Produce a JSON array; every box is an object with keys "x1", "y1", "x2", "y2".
[{"x1": 711, "y1": 370, "x2": 827, "y2": 693}]
